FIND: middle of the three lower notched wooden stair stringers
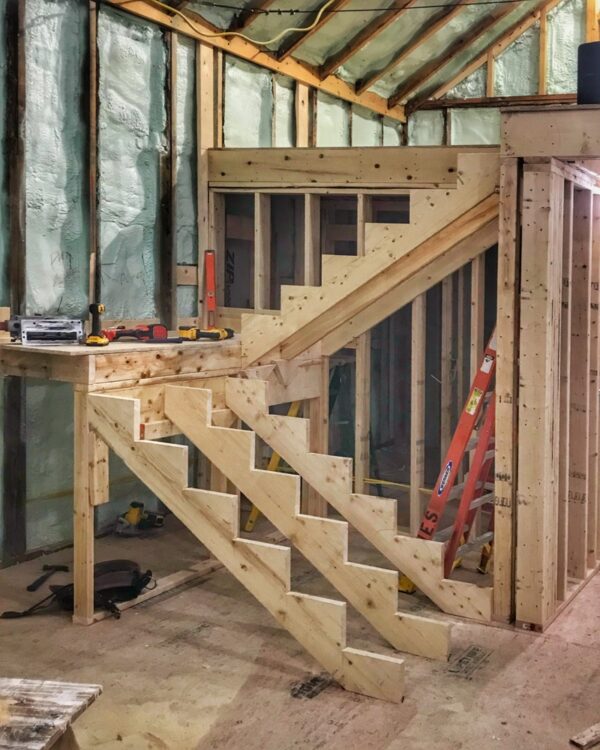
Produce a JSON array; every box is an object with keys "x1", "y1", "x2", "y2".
[{"x1": 165, "y1": 380, "x2": 449, "y2": 659}]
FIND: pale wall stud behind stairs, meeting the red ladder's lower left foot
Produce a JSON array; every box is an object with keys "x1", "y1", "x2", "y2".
[{"x1": 410, "y1": 294, "x2": 427, "y2": 536}]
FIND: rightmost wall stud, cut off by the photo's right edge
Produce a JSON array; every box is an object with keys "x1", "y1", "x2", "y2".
[{"x1": 587, "y1": 195, "x2": 600, "y2": 568}]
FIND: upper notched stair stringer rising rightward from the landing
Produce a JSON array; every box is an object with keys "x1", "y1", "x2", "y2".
[{"x1": 242, "y1": 152, "x2": 500, "y2": 367}]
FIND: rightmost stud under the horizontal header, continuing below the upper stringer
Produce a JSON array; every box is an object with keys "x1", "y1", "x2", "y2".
[{"x1": 354, "y1": 193, "x2": 372, "y2": 494}]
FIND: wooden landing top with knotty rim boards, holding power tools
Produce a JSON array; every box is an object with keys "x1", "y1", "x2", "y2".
[{"x1": 0, "y1": 336, "x2": 241, "y2": 390}]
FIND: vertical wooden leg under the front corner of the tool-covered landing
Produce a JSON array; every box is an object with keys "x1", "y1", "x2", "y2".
[{"x1": 73, "y1": 390, "x2": 94, "y2": 625}]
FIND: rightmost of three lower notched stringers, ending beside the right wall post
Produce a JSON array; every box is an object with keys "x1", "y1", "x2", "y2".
[{"x1": 225, "y1": 378, "x2": 492, "y2": 621}]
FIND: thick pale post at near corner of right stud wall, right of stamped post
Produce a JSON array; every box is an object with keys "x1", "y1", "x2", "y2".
[{"x1": 516, "y1": 167, "x2": 564, "y2": 629}]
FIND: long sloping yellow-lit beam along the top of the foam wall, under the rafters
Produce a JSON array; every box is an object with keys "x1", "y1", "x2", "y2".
[{"x1": 105, "y1": 0, "x2": 405, "y2": 122}]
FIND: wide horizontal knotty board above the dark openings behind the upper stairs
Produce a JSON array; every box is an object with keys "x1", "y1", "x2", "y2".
[{"x1": 208, "y1": 146, "x2": 468, "y2": 190}]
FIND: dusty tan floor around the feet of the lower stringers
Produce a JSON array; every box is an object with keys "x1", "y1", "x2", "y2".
[{"x1": 0, "y1": 519, "x2": 600, "y2": 750}]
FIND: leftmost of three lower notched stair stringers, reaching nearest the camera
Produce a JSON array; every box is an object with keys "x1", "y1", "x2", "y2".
[{"x1": 88, "y1": 391, "x2": 404, "y2": 702}]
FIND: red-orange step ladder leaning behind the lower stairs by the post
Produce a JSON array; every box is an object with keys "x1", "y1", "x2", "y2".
[{"x1": 417, "y1": 331, "x2": 496, "y2": 578}]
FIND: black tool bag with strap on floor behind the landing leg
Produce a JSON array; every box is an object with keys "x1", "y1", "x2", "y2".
[{"x1": 0, "y1": 560, "x2": 156, "y2": 619}]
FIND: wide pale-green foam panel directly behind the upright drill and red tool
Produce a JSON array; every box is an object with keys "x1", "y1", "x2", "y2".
[{"x1": 98, "y1": 7, "x2": 167, "y2": 319}]
